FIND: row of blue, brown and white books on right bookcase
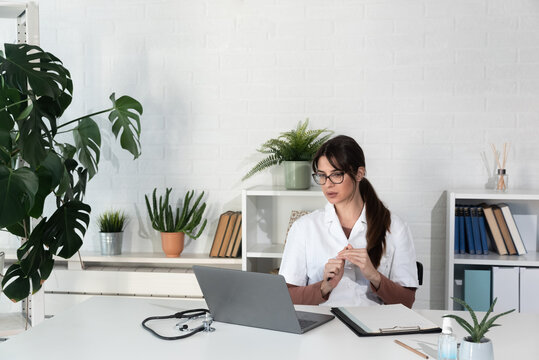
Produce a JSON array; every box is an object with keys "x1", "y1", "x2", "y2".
[{"x1": 454, "y1": 204, "x2": 527, "y2": 255}]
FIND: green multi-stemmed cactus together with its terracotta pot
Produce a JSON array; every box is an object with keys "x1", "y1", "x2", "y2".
[{"x1": 144, "y1": 188, "x2": 207, "y2": 257}]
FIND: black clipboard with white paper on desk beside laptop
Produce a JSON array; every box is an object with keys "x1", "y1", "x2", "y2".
[{"x1": 331, "y1": 304, "x2": 442, "y2": 336}]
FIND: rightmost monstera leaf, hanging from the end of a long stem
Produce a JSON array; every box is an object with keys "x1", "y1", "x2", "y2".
[{"x1": 109, "y1": 93, "x2": 142, "y2": 159}]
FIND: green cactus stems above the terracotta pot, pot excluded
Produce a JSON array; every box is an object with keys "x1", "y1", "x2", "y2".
[{"x1": 144, "y1": 188, "x2": 207, "y2": 239}]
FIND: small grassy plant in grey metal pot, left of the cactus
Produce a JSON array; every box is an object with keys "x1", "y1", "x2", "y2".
[{"x1": 97, "y1": 210, "x2": 128, "y2": 255}]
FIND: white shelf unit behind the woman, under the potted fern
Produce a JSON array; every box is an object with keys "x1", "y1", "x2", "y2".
[{"x1": 242, "y1": 186, "x2": 326, "y2": 272}]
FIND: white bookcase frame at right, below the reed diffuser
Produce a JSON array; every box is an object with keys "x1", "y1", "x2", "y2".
[{"x1": 445, "y1": 190, "x2": 539, "y2": 310}]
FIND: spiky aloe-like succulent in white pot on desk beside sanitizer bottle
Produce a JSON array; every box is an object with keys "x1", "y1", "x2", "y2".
[{"x1": 444, "y1": 298, "x2": 515, "y2": 360}]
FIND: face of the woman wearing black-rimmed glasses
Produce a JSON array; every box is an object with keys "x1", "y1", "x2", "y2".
[{"x1": 317, "y1": 156, "x2": 364, "y2": 205}]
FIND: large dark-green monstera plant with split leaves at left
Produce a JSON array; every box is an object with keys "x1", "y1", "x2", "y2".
[{"x1": 0, "y1": 44, "x2": 142, "y2": 301}]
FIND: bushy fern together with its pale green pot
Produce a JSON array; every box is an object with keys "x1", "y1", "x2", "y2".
[{"x1": 242, "y1": 119, "x2": 333, "y2": 189}]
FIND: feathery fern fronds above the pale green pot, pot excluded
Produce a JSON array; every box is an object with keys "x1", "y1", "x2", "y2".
[{"x1": 242, "y1": 119, "x2": 333, "y2": 180}]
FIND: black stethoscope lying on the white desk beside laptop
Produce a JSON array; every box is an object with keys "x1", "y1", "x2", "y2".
[{"x1": 142, "y1": 309, "x2": 215, "y2": 340}]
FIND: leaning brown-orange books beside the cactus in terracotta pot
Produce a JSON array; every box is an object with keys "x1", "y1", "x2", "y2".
[{"x1": 210, "y1": 211, "x2": 241, "y2": 258}]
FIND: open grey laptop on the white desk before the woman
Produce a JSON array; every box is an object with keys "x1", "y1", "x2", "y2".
[{"x1": 193, "y1": 265, "x2": 334, "y2": 334}]
